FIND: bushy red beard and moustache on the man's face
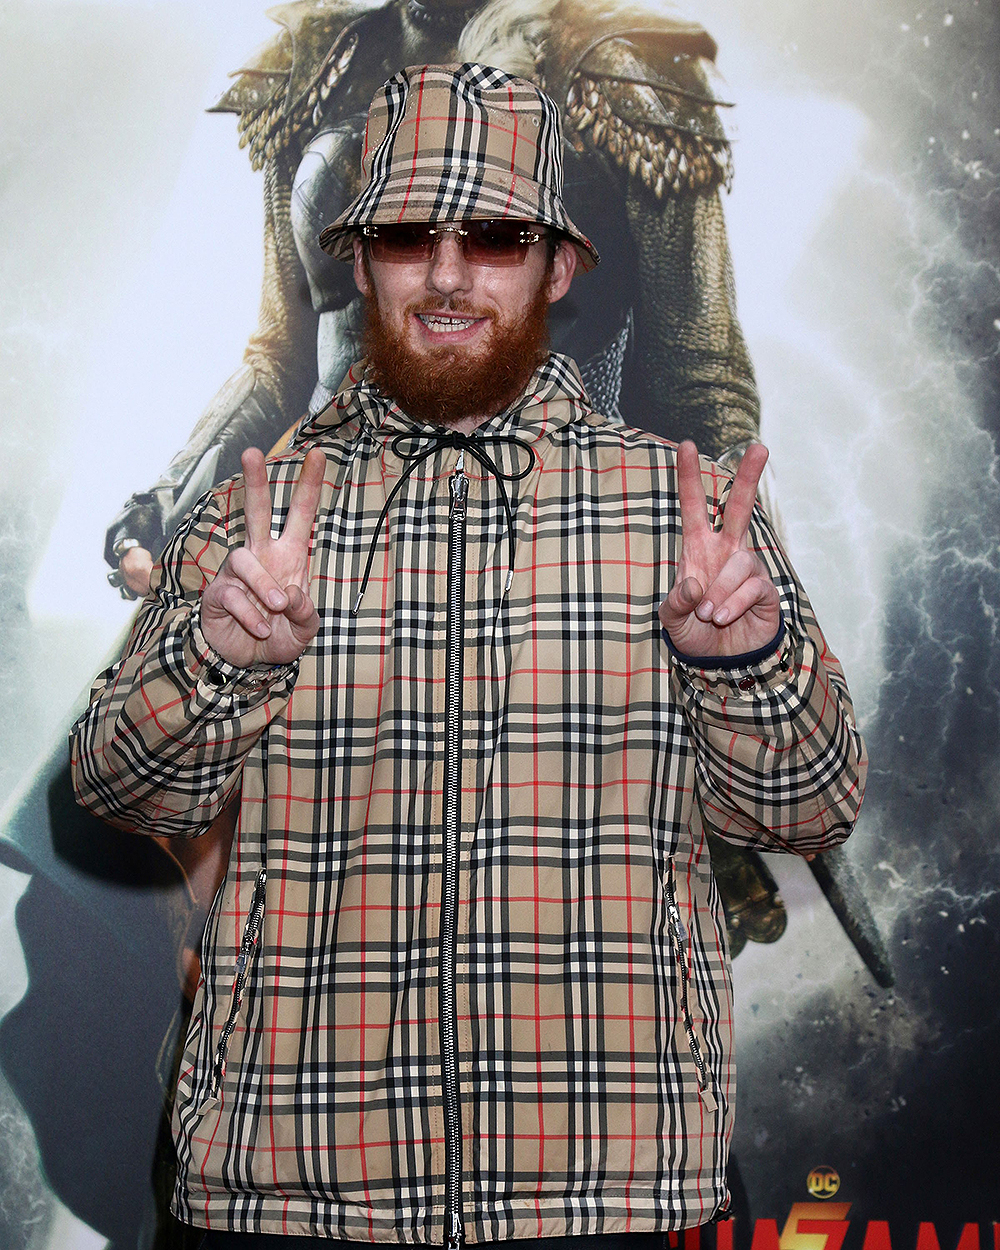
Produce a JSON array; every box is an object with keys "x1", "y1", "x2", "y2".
[{"x1": 363, "y1": 280, "x2": 549, "y2": 425}]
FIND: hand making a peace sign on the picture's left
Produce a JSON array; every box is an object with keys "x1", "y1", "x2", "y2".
[{"x1": 201, "y1": 448, "x2": 326, "y2": 669}]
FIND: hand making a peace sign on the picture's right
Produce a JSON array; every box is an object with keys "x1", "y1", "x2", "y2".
[{"x1": 660, "y1": 441, "x2": 781, "y2": 656}]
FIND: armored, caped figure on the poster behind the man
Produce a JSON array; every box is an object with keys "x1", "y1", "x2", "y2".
[{"x1": 0, "y1": 9, "x2": 891, "y2": 1246}]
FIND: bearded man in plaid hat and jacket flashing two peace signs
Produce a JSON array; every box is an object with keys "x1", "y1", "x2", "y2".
[{"x1": 74, "y1": 64, "x2": 864, "y2": 1250}]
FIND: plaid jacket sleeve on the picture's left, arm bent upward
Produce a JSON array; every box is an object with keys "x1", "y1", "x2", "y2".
[{"x1": 70, "y1": 488, "x2": 298, "y2": 838}]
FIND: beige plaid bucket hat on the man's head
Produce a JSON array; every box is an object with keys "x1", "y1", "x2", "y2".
[{"x1": 319, "y1": 63, "x2": 600, "y2": 270}]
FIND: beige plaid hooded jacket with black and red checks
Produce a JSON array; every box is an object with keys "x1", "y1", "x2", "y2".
[{"x1": 74, "y1": 356, "x2": 864, "y2": 1243}]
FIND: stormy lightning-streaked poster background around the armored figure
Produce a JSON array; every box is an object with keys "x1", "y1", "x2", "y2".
[{"x1": 0, "y1": 0, "x2": 1000, "y2": 1250}]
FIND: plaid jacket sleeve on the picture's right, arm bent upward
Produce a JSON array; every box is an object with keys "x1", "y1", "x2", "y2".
[{"x1": 673, "y1": 479, "x2": 868, "y2": 855}]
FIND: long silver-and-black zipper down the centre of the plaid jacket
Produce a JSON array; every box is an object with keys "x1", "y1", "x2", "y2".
[{"x1": 439, "y1": 451, "x2": 469, "y2": 1250}]
